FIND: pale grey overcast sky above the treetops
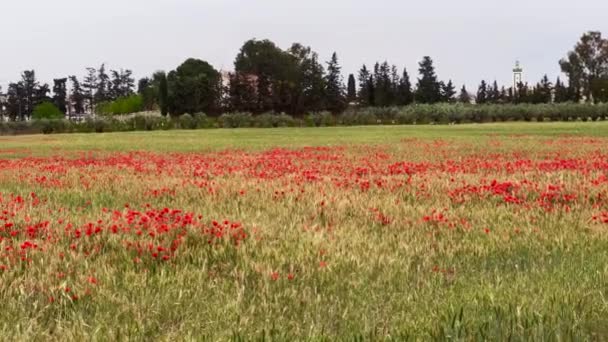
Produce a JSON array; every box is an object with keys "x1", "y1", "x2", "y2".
[{"x1": 0, "y1": 0, "x2": 608, "y2": 91}]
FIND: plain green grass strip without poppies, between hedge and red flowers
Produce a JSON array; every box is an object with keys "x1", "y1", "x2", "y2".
[{"x1": 0, "y1": 122, "x2": 608, "y2": 152}]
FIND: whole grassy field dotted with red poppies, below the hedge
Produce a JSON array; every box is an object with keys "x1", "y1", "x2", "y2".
[{"x1": 0, "y1": 122, "x2": 608, "y2": 340}]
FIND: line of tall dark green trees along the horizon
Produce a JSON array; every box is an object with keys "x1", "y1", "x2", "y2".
[{"x1": 0, "y1": 31, "x2": 608, "y2": 120}]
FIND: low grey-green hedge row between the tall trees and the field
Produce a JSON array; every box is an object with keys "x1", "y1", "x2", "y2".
[{"x1": 0, "y1": 103, "x2": 608, "y2": 134}]
